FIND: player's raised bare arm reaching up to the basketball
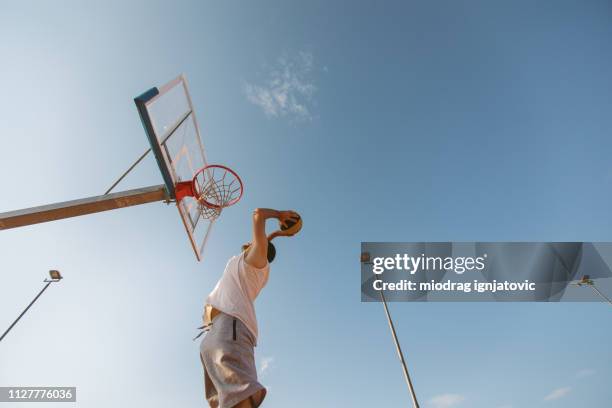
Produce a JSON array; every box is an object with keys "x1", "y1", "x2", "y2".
[{"x1": 244, "y1": 208, "x2": 299, "y2": 268}]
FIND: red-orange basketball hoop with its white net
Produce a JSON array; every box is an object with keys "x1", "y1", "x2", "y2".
[{"x1": 175, "y1": 164, "x2": 243, "y2": 219}]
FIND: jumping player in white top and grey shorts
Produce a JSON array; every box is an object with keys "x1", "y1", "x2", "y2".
[{"x1": 200, "y1": 208, "x2": 302, "y2": 408}]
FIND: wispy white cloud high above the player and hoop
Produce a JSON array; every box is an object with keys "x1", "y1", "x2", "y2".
[{"x1": 244, "y1": 51, "x2": 317, "y2": 119}]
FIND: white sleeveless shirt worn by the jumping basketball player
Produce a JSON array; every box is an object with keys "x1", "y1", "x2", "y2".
[{"x1": 206, "y1": 252, "x2": 270, "y2": 344}]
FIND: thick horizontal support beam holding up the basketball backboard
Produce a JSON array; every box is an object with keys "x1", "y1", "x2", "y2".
[{"x1": 0, "y1": 184, "x2": 170, "y2": 230}]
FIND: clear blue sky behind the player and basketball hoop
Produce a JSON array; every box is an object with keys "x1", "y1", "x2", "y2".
[{"x1": 0, "y1": 1, "x2": 612, "y2": 408}]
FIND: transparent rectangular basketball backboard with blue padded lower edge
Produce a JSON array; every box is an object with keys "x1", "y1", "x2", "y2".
[{"x1": 134, "y1": 75, "x2": 214, "y2": 261}]
